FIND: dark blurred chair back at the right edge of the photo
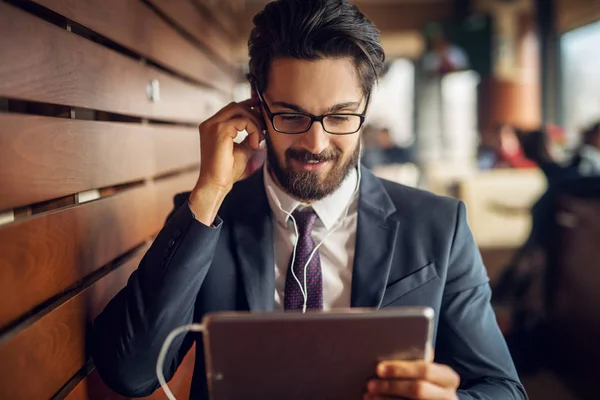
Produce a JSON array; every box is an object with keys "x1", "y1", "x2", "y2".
[{"x1": 546, "y1": 177, "x2": 600, "y2": 399}]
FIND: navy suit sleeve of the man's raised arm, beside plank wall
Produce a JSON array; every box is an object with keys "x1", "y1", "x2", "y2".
[{"x1": 89, "y1": 196, "x2": 222, "y2": 397}]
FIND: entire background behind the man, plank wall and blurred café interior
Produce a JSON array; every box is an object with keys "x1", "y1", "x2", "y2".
[{"x1": 0, "y1": 0, "x2": 600, "y2": 400}]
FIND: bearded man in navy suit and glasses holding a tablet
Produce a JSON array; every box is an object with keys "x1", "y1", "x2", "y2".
[{"x1": 92, "y1": 0, "x2": 526, "y2": 400}]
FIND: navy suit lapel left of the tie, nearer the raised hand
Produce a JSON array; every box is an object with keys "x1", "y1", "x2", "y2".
[{"x1": 232, "y1": 168, "x2": 275, "y2": 311}]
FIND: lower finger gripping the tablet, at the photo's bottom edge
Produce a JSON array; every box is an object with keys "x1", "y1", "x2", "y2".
[{"x1": 367, "y1": 379, "x2": 456, "y2": 400}]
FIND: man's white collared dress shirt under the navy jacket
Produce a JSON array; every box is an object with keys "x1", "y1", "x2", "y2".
[{"x1": 263, "y1": 163, "x2": 358, "y2": 310}]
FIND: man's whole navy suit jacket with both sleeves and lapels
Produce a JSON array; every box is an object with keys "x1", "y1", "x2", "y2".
[{"x1": 90, "y1": 168, "x2": 526, "y2": 400}]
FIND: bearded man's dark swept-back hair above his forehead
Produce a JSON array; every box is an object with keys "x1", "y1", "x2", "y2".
[{"x1": 248, "y1": 0, "x2": 385, "y2": 94}]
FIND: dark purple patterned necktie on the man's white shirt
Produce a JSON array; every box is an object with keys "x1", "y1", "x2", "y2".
[{"x1": 283, "y1": 209, "x2": 323, "y2": 311}]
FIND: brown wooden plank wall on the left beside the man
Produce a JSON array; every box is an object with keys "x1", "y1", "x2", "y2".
[{"x1": 0, "y1": 0, "x2": 236, "y2": 400}]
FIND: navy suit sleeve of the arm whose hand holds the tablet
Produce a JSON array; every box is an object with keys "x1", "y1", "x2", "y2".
[{"x1": 436, "y1": 202, "x2": 527, "y2": 400}]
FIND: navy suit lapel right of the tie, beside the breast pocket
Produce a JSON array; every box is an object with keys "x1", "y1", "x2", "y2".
[{"x1": 350, "y1": 168, "x2": 402, "y2": 308}]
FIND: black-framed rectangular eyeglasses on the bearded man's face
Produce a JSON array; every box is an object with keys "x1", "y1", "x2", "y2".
[{"x1": 256, "y1": 90, "x2": 371, "y2": 135}]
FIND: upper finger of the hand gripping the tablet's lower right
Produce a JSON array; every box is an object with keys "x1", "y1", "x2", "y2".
[{"x1": 377, "y1": 361, "x2": 460, "y2": 388}]
